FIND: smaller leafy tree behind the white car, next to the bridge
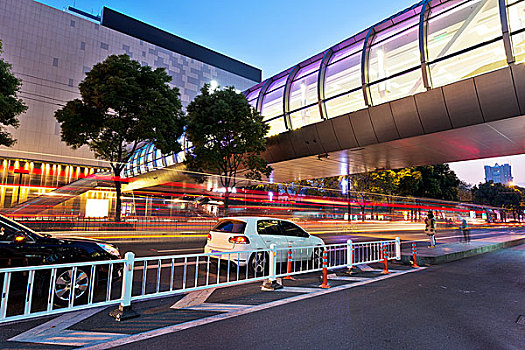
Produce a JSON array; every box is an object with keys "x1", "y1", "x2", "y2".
[{"x1": 186, "y1": 84, "x2": 272, "y2": 212}]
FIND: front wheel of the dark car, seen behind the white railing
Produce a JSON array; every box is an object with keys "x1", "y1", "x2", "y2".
[{"x1": 54, "y1": 268, "x2": 89, "y2": 305}]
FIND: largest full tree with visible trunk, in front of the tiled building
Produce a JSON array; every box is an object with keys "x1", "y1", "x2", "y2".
[{"x1": 55, "y1": 55, "x2": 185, "y2": 221}]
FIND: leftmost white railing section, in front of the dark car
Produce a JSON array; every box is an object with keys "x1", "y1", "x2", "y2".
[{"x1": 0, "y1": 260, "x2": 125, "y2": 322}]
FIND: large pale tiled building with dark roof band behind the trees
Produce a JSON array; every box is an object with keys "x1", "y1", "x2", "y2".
[{"x1": 0, "y1": 0, "x2": 261, "y2": 207}]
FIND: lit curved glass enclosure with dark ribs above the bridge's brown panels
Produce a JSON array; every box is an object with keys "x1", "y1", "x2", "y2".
[{"x1": 244, "y1": 0, "x2": 525, "y2": 136}]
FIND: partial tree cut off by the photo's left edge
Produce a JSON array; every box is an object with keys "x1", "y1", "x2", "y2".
[{"x1": 0, "y1": 41, "x2": 27, "y2": 147}]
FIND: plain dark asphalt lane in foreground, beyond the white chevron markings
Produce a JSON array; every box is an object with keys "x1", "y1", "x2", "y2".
[{"x1": 111, "y1": 245, "x2": 525, "y2": 350}]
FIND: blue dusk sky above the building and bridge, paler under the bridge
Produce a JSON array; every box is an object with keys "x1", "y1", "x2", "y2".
[{"x1": 39, "y1": 0, "x2": 525, "y2": 186}]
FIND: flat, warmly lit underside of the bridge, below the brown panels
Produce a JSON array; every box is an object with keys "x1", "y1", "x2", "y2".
[{"x1": 272, "y1": 116, "x2": 525, "y2": 182}]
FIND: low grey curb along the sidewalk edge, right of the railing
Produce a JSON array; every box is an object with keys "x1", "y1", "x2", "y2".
[{"x1": 401, "y1": 238, "x2": 525, "y2": 265}]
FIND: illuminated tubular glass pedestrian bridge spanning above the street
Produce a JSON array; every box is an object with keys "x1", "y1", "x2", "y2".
[{"x1": 122, "y1": 0, "x2": 525, "y2": 181}]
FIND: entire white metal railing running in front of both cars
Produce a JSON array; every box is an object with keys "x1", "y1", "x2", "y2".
[{"x1": 0, "y1": 238, "x2": 401, "y2": 323}]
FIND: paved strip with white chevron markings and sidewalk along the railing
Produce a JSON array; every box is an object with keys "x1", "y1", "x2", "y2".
[{"x1": 0, "y1": 233, "x2": 525, "y2": 349}]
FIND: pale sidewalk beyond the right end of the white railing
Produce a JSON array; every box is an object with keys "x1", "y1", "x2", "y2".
[{"x1": 401, "y1": 233, "x2": 525, "y2": 266}]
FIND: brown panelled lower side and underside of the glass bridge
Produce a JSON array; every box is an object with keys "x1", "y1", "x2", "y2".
[{"x1": 265, "y1": 64, "x2": 525, "y2": 182}]
